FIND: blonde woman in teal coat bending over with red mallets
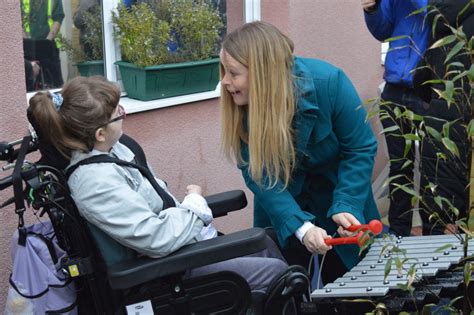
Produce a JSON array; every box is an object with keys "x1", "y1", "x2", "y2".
[{"x1": 220, "y1": 22, "x2": 379, "y2": 283}]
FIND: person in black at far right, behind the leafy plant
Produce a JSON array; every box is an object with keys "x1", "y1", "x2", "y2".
[{"x1": 414, "y1": 0, "x2": 474, "y2": 234}]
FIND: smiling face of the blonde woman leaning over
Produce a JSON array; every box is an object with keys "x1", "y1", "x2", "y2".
[{"x1": 220, "y1": 49, "x2": 249, "y2": 106}]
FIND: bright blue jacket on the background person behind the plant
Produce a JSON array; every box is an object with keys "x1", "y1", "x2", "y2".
[{"x1": 364, "y1": 0, "x2": 431, "y2": 87}]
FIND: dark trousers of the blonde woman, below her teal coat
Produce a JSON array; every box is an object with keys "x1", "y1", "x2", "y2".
[{"x1": 282, "y1": 236, "x2": 347, "y2": 284}]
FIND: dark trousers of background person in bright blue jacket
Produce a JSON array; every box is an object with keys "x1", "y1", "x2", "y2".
[{"x1": 380, "y1": 83, "x2": 415, "y2": 236}]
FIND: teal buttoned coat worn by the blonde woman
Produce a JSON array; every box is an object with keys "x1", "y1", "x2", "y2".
[{"x1": 242, "y1": 57, "x2": 379, "y2": 268}]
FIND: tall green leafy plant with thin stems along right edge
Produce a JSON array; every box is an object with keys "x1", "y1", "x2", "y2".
[{"x1": 368, "y1": 1, "x2": 474, "y2": 314}]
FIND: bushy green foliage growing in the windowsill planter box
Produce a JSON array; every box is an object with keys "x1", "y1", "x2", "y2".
[{"x1": 112, "y1": 0, "x2": 224, "y2": 67}]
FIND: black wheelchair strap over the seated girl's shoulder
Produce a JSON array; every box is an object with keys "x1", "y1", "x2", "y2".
[{"x1": 66, "y1": 154, "x2": 176, "y2": 209}]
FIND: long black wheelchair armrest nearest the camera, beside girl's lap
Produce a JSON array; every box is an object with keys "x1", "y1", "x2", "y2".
[{"x1": 108, "y1": 228, "x2": 266, "y2": 289}]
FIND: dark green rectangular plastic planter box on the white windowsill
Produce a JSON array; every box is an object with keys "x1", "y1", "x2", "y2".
[{"x1": 115, "y1": 58, "x2": 219, "y2": 101}]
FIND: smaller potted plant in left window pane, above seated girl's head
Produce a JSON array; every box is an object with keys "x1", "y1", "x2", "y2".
[{"x1": 57, "y1": 5, "x2": 104, "y2": 76}]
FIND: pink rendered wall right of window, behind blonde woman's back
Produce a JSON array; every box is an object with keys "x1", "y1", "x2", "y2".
[{"x1": 261, "y1": 0, "x2": 387, "y2": 178}]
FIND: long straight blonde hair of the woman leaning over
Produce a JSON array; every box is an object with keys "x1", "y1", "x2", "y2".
[{"x1": 221, "y1": 22, "x2": 296, "y2": 187}]
